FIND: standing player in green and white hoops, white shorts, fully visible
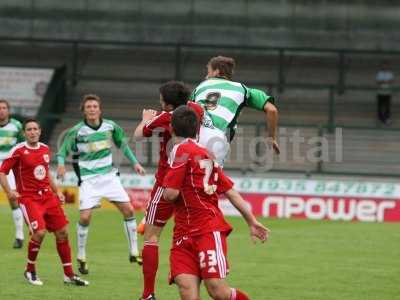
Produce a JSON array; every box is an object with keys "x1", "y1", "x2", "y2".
[{"x1": 57, "y1": 95, "x2": 145, "y2": 274}]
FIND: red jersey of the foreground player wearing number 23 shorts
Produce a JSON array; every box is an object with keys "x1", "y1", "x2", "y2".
[{"x1": 163, "y1": 139, "x2": 233, "y2": 239}]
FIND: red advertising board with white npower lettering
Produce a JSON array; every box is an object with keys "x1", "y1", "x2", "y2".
[{"x1": 220, "y1": 193, "x2": 400, "y2": 222}]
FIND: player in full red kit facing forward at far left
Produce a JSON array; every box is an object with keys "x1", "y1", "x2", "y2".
[{"x1": 0, "y1": 119, "x2": 89, "y2": 286}]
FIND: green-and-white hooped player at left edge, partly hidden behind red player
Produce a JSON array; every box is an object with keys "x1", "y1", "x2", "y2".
[{"x1": 0, "y1": 99, "x2": 24, "y2": 249}]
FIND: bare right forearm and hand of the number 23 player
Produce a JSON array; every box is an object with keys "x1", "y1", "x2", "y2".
[{"x1": 225, "y1": 189, "x2": 270, "y2": 243}]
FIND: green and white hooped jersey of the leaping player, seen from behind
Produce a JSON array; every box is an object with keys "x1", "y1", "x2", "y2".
[{"x1": 191, "y1": 78, "x2": 274, "y2": 138}]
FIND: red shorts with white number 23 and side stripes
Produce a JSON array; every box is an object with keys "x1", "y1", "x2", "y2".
[{"x1": 169, "y1": 231, "x2": 229, "y2": 284}]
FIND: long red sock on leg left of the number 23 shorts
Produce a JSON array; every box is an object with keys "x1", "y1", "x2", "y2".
[{"x1": 142, "y1": 242, "x2": 158, "y2": 299}]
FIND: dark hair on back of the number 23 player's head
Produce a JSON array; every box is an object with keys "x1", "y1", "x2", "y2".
[{"x1": 171, "y1": 105, "x2": 199, "y2": 138}]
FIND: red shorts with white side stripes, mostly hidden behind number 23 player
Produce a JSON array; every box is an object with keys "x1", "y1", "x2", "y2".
[{"x1": 146, "y1": 183, "x2": 174, "y2": 227}]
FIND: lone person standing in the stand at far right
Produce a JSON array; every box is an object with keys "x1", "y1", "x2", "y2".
[{"x1": 375, "y1": 61, "x2": 394, "y2": 124}]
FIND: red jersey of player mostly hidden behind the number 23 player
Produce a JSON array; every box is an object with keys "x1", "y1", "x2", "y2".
[{"x1": 143, "y1": 102, "x2": 204, "y2": 185}]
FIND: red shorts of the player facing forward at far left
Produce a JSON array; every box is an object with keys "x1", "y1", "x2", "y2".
[{"x1": 20, "y1": 192, "x2": 68, "y2": 233}]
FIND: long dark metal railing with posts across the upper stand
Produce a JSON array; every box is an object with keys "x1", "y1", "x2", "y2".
[{"x1": 0, "y1": 36, "x2": 400, "y2": 86}]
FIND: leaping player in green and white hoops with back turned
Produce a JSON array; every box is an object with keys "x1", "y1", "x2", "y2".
[{"x1": 191, "y1": 56, "x2": 280, "y2": 166}]
